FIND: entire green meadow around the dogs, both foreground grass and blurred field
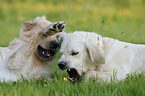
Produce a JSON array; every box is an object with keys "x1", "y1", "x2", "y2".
[{"x1": 0, "y1": 0, "x2": 145, "y2": 96}]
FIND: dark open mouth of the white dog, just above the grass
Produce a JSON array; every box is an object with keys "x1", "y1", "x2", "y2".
[{"x1": 67, "y1": 68, "x2": 81, "y2": 83}]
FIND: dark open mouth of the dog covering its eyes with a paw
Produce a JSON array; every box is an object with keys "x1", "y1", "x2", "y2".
[{"x1": 38, "y1": 45, "x2": 55, "y2": 61}]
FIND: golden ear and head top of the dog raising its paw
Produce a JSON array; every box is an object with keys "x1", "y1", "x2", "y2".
[{"x1": 20, "y1": 16, "x2": 51, "y2": 41}]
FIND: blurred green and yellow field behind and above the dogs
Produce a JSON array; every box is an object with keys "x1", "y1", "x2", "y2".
[{"x1": 0, "y1": 0, "x2": 145, "y2": 46}]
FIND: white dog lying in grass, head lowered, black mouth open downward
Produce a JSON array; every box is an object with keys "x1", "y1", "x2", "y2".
[{"x1": 58, "y1": 31, "x2": 145, "y2": 82}]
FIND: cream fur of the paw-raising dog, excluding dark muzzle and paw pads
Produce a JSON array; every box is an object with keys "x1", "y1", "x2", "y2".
[{"x1": 0, "y1": 16, "x2": 59, "y2": 81}]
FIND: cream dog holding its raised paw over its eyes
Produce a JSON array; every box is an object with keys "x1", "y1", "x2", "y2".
[{"x1": 0, "y1": 16, "x2": 65, "y2": 81}]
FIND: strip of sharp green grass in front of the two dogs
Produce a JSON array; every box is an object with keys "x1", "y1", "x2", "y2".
[{"x1": 0, "y1": 75, "x2": 145, "y2": 96}]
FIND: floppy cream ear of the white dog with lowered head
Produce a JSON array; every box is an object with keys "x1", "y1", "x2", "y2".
[{"x1": 86, "y1": 36, "x2": 105, "y2": 64}]
